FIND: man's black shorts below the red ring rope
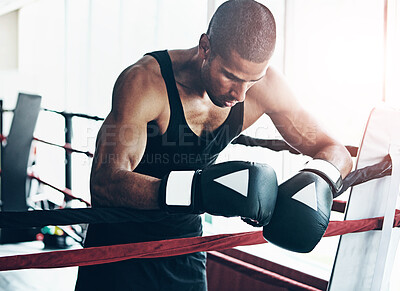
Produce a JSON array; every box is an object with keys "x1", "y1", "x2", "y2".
[{"x1": 75, "y1": 252, "x2": 207, "y2": 291}]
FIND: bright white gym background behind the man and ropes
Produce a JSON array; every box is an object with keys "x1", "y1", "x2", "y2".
[{"x1": 0, "y1": 0, "x2": 400, "y2": 286}]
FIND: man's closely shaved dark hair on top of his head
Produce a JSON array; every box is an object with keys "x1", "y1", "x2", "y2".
[{"x1": 207, "y1": 0, "x2": 276, "y2": 63}]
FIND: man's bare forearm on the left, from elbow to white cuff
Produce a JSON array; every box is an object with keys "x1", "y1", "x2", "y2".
[{"x1": 90, "y1": 170, "x2": 160, "y2": 210}]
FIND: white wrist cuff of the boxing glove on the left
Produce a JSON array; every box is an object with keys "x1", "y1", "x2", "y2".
[{"x1": 165, "y1": 171, "x2": 195, "y2": 206}]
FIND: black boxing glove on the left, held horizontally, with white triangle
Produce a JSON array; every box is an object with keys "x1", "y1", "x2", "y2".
[{"x1": 159, "y1": 161, "x2": 278, "y2": 225}]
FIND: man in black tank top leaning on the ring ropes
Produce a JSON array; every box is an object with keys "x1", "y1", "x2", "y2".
[{"x1": 76, "y1": 0, "x2": 352, "y2": 290}]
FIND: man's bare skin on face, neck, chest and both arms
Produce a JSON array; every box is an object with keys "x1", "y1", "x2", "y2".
[{"x1": 90, "y1": 35, "x2": 352, "y2": 209}]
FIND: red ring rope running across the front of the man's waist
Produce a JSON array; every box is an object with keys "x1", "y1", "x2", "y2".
[{"x1": 0, "y1": 210, "x2": 400, "y2": 271}]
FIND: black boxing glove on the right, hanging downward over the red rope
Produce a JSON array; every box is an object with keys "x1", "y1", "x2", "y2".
[{"x1": 263, "y1": 159, "x2": 342, "y2": 253}]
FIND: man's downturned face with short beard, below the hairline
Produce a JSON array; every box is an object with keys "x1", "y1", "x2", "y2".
[{"x1": 201, "y1": 51, "x2": 268, "y2": 107}]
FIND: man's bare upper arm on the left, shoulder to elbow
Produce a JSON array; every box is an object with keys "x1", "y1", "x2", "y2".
[{"x1": 98, "y1": 65, "x2": 163, "y2": 171}]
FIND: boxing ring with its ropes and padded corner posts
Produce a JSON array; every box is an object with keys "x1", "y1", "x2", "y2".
[{"x1": 0, "y1": 94, "x2": 400, "y2": 291}]
